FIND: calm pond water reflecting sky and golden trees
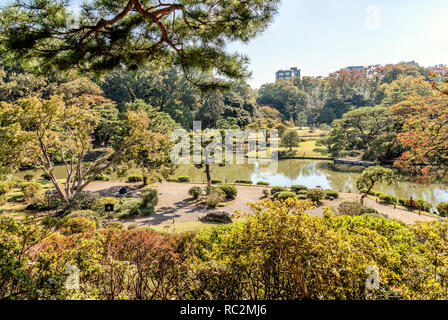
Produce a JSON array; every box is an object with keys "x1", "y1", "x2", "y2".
[{"x1": 18, "y1": 160, "x2": 448, "y2": 205}]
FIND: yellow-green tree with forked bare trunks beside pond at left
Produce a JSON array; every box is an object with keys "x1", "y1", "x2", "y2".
[{"x1": 0, "y1": 96, "x2": 170, "y2": 201}]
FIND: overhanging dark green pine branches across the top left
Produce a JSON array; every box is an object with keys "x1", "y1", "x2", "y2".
[{"x1": 0, "y1": 0, "x2": 279, "y2": 87}]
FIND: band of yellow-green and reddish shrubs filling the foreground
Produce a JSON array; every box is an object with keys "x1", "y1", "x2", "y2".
[{"x1": 0, "y1": 199, "x2": 448, "y2": 300}]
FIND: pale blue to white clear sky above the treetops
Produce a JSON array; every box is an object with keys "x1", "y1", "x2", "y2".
[{"x1": 229, "y1": 0, "x2": 448, "y2": 88}]
